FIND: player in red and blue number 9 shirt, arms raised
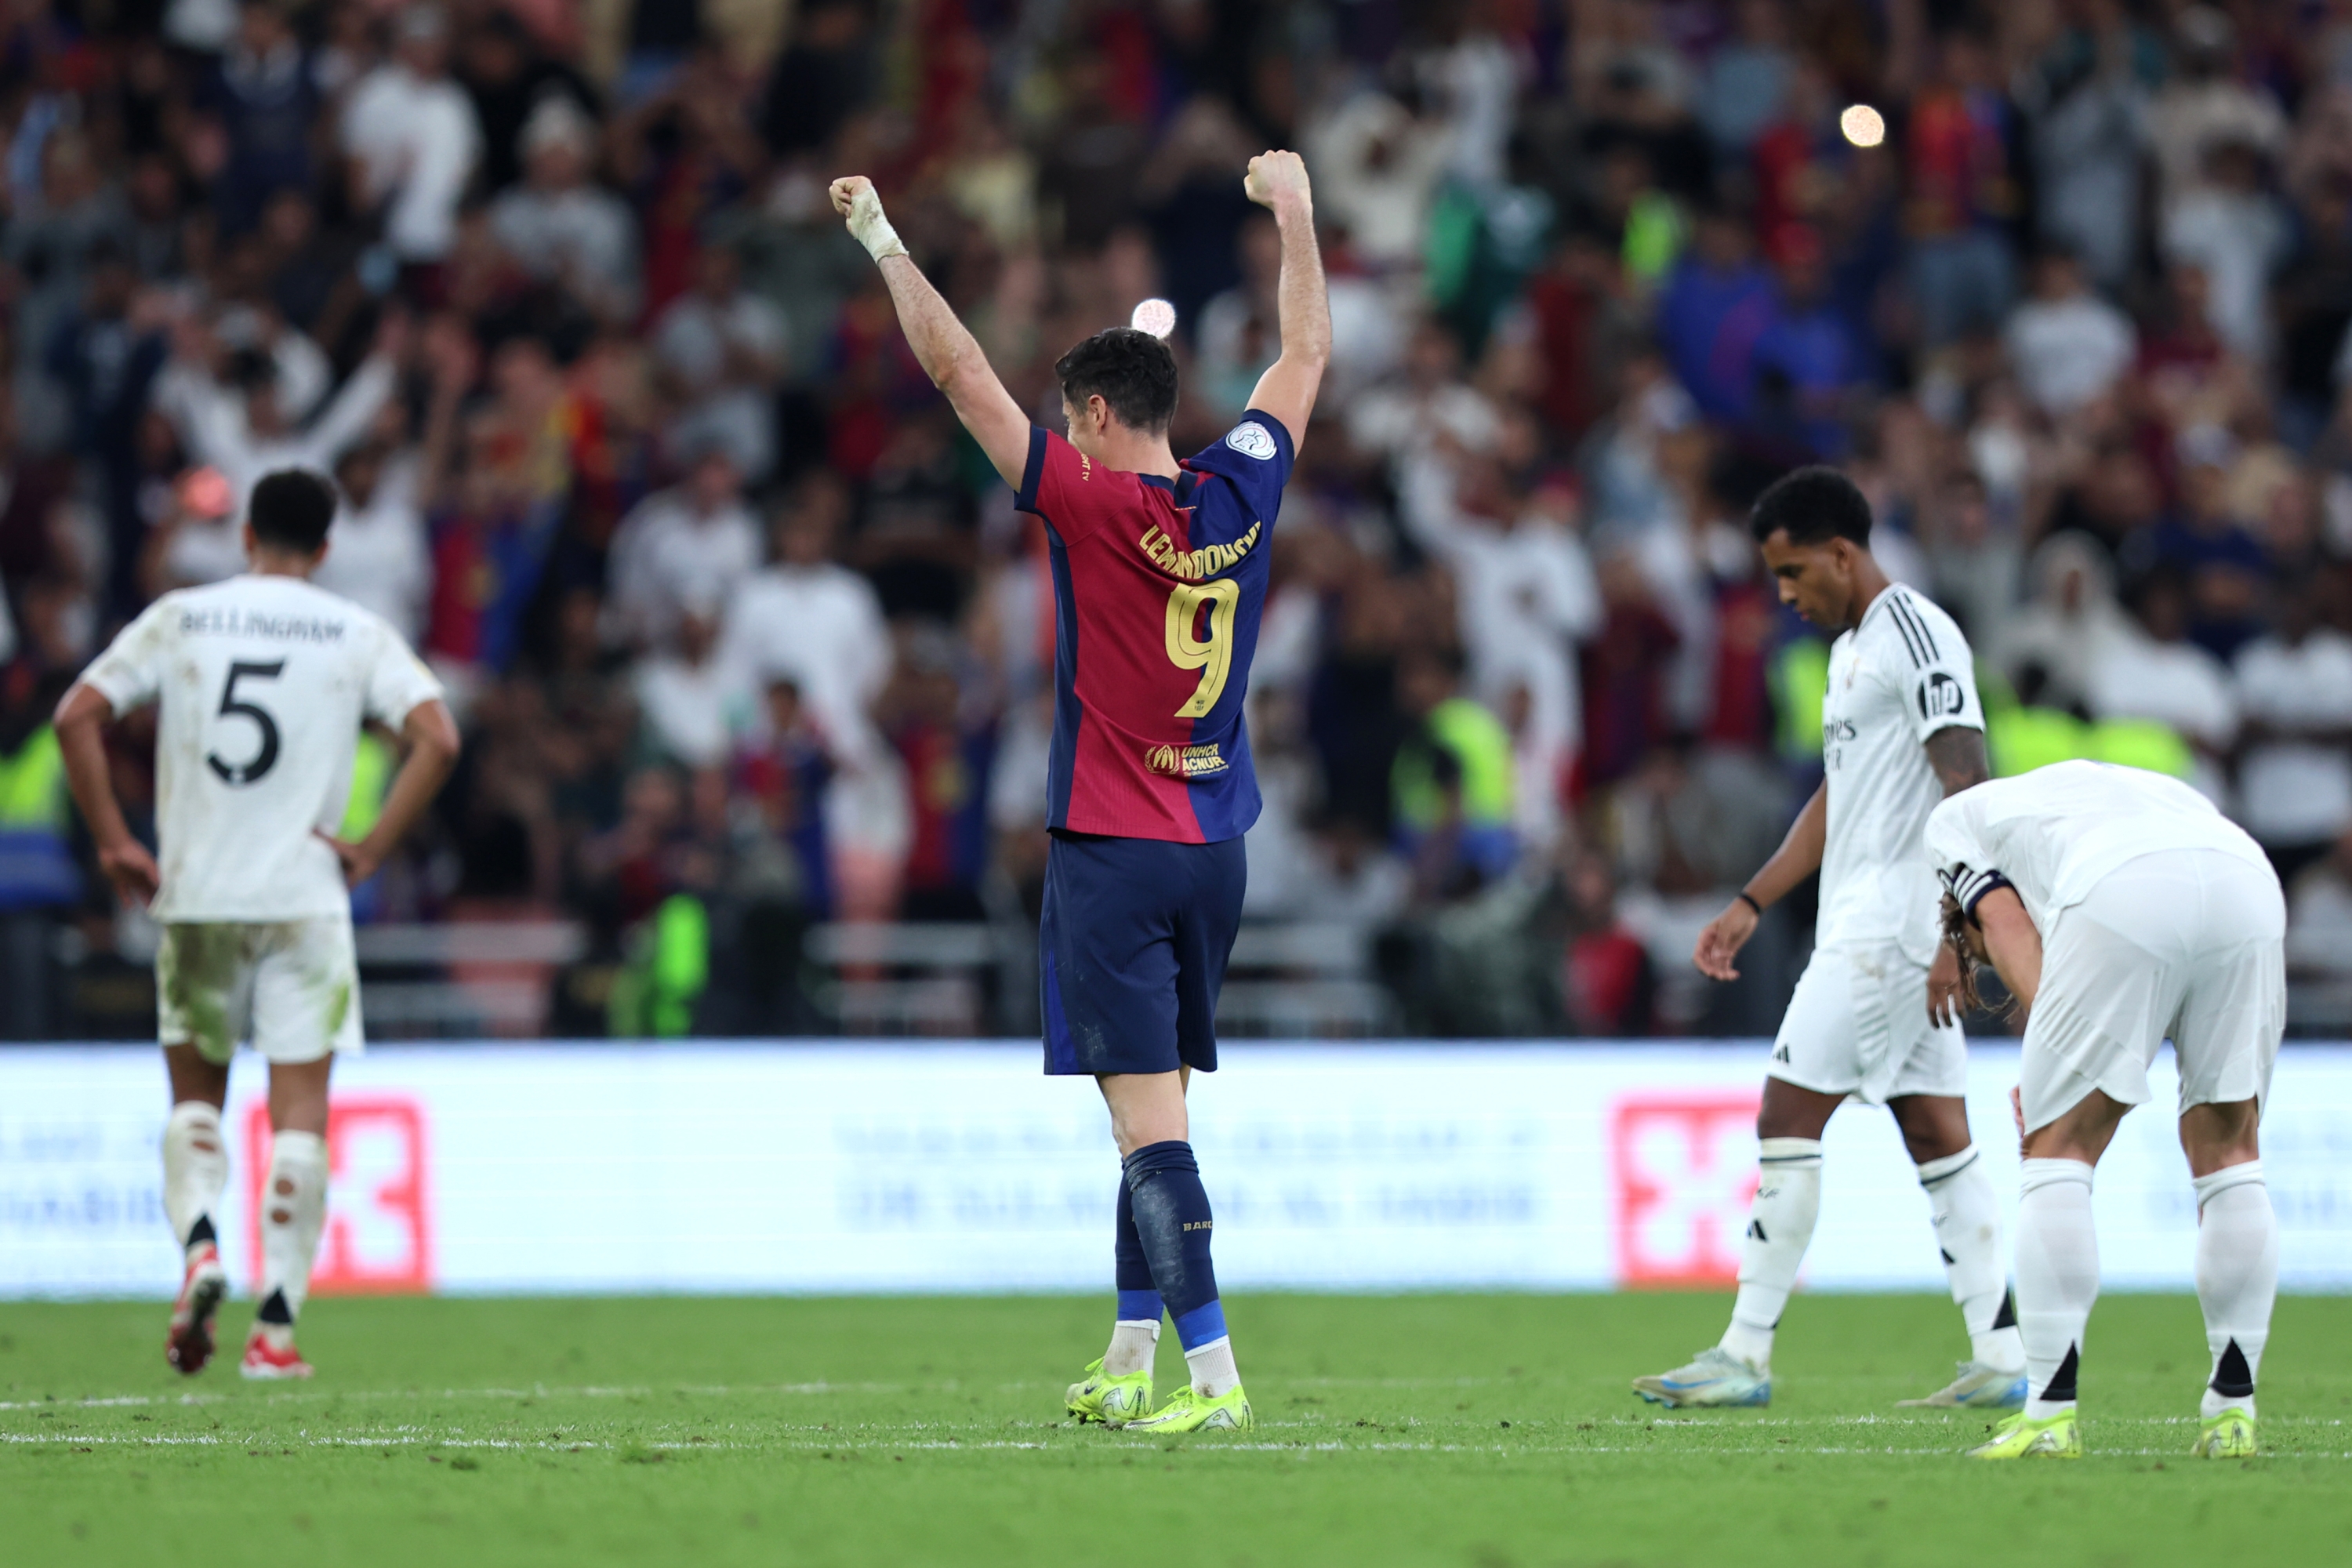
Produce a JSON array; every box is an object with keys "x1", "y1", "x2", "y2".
[{"x1": 833, "y1": 153, "x2": 1331, "y2": 1432}]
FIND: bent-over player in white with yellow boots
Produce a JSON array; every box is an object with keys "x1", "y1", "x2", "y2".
[{"x1": 1926, "y1": 762, "x2": 2286, "y2": 1460}]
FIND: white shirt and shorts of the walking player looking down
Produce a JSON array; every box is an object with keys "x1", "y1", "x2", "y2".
[{"x1": 1766, "y1": 583, "x2": 1985, "y2": 1105}]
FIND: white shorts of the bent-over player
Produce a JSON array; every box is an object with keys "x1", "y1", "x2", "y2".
[{"x1": 2018, "y1": 848, "x2": 2286, "y2": 1131}]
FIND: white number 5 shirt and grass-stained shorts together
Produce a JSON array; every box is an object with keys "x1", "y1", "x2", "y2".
[{"x1": 82, "y1": 576, "x2": 442, "y2": 1062}]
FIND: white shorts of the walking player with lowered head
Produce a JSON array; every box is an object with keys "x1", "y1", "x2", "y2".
[{"x1": 1764, "y1": 942, "x2": 1969, "y2": 1105}]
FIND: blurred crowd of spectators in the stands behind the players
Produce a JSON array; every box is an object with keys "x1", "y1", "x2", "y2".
[{"x1": 0, "y1": 0, "x2": 2352, "y2": 1034}]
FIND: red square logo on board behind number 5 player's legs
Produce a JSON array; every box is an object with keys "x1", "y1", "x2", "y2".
[{"x1": 245, "y1": 1095, "x2": 433, "y2": 1295}]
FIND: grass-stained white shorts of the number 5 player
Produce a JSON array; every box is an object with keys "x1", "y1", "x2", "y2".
[{"x1": 155, "y1": 914, "x2": 365, "y2": 1065}]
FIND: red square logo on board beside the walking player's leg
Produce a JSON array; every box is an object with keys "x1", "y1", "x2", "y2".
[{"x1": 1609, "y1": 1095, "x2": 1757, "y2": 1286}]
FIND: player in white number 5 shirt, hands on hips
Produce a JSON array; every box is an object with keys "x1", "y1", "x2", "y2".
[{"x1": 56, "y1": 468, "x2": 459, "y2": 1377}]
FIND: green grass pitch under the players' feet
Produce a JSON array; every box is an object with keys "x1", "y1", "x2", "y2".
[{"x1": 0, "y1": 1295, "x2": 2352, "y2": 1568}]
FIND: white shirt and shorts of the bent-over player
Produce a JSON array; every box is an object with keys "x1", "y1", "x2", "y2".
[{"x1": 1926, "y1": 762, "x2": 2286, "y2": 1128}]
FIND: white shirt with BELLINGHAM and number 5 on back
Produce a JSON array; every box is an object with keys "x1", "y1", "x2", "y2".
[{"x1": 82, "y1": 576, "x2": 442, "y2": 921}]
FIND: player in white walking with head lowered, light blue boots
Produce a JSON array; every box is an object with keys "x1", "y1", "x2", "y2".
[{"x1": 1632, "y1": 468, "x2": 2025, "y2": 1406}]
